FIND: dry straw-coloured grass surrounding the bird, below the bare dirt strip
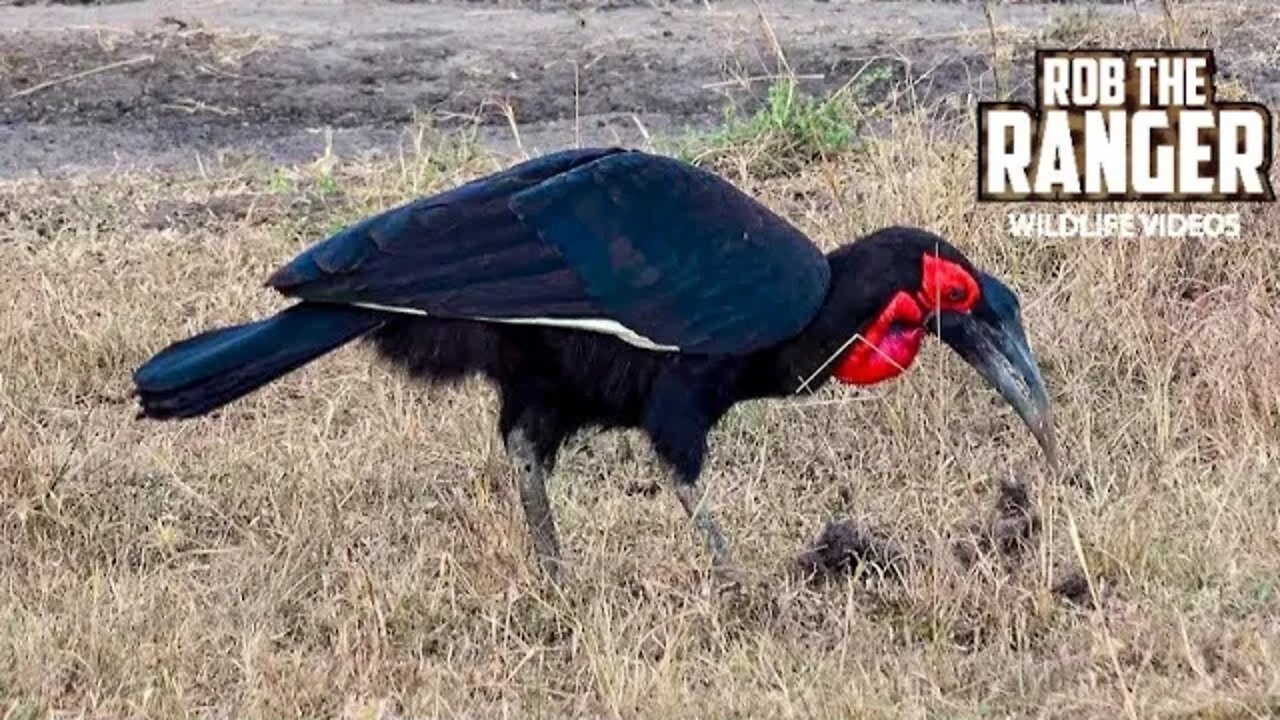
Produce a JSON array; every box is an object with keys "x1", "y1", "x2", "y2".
[{"x1": 0, "y1": 47, "x2": 1280, "y2": 719}]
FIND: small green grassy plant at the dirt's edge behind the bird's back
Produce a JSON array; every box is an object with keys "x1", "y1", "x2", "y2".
[{"x1": 676, "y1": 79, "x2": 858, "y2": 177}]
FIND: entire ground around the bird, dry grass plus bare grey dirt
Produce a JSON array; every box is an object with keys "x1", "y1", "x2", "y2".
[{"x1": 0, "y1": 0, "x2": 1280, "y2": 720}]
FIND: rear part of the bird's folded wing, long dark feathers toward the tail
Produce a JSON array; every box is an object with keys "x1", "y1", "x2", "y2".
[{"x1": 268, "y1": 150, "x2": 612, "y2": 318}]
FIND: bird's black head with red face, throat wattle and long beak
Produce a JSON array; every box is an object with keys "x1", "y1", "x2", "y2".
[{"x1": 806, "y1": 227, "x2": 1057, "y2": 462}]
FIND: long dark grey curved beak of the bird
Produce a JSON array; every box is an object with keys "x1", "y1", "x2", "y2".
[{"x1": 927, "y1": 273, "x2": 1057, "y2": 470}]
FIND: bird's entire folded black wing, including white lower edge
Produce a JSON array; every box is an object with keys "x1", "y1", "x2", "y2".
[{"x1": 270, "y1": 150, "x2": 829, "y2": 354}]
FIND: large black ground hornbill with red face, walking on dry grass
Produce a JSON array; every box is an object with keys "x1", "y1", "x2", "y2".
[{"x1": 134, "y1": 149, "x2": 1055, "y2": 578}]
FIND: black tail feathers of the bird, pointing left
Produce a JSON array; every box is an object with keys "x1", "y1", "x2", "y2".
[{"x1": 133, "y1": 302, "x2": 384, "y2": 420}]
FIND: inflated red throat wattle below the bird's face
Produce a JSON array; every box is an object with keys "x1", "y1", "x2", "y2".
[{"x1": 836, "y1": 292, "x2": 924, "y2": 386}]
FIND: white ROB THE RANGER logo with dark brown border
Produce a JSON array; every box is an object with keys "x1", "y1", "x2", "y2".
[{"x1": 978, "y1": 50, "x2": 1275, "y2": 202}]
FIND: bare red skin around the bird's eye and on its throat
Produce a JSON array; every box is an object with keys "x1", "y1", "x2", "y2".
[{"x1": 835, "y1": 254, "x2": 980, "y2": 386}]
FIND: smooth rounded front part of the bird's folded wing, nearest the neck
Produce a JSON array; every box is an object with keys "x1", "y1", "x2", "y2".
[{"x1": 511, "y1": 152, "x2": 831, "y2": 354}]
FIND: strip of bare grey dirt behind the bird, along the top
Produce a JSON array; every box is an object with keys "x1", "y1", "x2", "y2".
[{"x1": 0, "y1": 0, "x2": 1167, "y2": 177}]
